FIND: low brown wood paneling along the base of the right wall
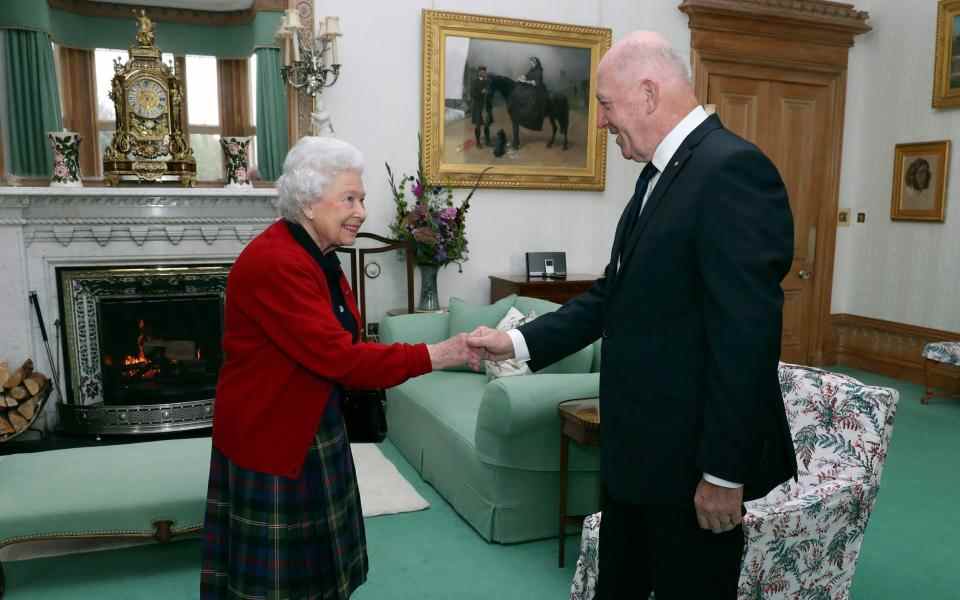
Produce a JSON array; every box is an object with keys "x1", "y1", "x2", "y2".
[{"x1": 831, "y1": 314, "x2": 960, "y2": 389}]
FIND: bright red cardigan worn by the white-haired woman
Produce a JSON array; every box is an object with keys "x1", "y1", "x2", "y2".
[{"x1": 213, "y1": 221, "x2": 431, "y2": 477}]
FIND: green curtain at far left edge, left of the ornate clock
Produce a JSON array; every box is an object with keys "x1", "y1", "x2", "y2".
[{"x1": 3, "y1": 29, "x2": 63, "y2": 177}]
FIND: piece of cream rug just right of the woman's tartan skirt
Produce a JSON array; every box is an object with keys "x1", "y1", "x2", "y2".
[{"x1": 350, "y1": 444, "x2": 430, "y2": 517}]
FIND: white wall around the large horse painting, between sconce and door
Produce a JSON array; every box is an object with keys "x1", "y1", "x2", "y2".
[{"x1": 316, "y1": 0, "x2": 690, "y2": 315}]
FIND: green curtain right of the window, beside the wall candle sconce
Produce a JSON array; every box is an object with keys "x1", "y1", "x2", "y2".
[{"x1": 256, "y1": 48, "x2": 288, "y2": 181}]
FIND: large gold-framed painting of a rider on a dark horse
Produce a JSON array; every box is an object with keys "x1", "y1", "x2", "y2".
[{"x1": 422, "y1": 10, "x2": 612, "y2": 190}]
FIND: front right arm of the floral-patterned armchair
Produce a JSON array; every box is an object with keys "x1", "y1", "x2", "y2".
[{"x1": 740, "y1": 479, "x2": 871, "y2": 598}]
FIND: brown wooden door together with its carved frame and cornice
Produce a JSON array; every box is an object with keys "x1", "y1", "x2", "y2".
[{"x1": 680, "y1": 0, "x2": 870, "y2": 364}]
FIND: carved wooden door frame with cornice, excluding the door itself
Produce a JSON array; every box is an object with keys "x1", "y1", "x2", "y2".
[{"x1": 679, "y1": 0, "x2": 870, "y2": 365}]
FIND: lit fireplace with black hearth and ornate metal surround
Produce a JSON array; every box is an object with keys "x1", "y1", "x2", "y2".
[{"x1": 57, "y1": 265, "x2": 229, "y2": 434}]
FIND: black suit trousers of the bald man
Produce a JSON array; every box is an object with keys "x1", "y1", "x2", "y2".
[{"x1": 596, "y1": 494, "x2": 744, "y2": 600}]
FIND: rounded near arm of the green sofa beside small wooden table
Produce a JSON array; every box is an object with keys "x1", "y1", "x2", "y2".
[{"x1": 475, "y1": 373, "x2": 600, "y2": 471}]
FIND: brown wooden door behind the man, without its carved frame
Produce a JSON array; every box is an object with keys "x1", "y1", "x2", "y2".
[{"x1": 707, "y1": 72, "x2": 831, "y2": 364}]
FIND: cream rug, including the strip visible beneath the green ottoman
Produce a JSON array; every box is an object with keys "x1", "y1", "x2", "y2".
[{"x1": 0, "y1": 444, "x2": 430, "y2": 561}]
